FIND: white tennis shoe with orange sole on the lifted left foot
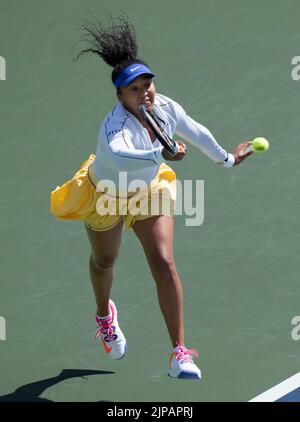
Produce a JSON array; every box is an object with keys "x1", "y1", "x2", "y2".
[{"x1": 95, "y1": 299, "x2": 127, "y2": 359}]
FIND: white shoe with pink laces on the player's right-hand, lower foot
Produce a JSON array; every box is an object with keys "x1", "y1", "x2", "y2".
[{"x1": 169, "y1": 343, "x2": 201, "y2": 379}]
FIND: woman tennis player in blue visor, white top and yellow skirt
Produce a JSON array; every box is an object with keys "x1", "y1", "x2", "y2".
[{"x1": 51, "y1": 16, "x2": 252, "y2": 379}]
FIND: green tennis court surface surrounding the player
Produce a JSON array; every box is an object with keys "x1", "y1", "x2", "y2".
[{"x1": 0, "y1": 0, "x2": 300, "y2": 402}]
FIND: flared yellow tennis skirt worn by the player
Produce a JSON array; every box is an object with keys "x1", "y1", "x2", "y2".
[{"x1": 50, "y1": 154, "x2": 176, "y2": 231}]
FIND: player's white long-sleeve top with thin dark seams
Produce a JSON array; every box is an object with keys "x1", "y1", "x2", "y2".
[{"x1": 92, "y1": 94, "x2": 234, "y2": 195}]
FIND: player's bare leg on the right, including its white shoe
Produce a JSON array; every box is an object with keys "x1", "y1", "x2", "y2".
[{"x1": 133, "y1": 216, "x2": 201, "y2": 379}]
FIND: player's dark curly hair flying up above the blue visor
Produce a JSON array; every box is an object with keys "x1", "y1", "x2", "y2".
[{"x1": 74, "y1": 15, "x2": 148, "y2": 83}]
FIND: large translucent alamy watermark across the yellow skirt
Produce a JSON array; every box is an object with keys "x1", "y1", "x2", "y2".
[{"x1": 96, "y1": 172, "x2": 204, "y2": 226}]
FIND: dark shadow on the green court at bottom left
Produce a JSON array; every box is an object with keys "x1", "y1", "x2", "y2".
[{"x1": 0, "y1": 369, "x2": 114, "y2": 402}]
